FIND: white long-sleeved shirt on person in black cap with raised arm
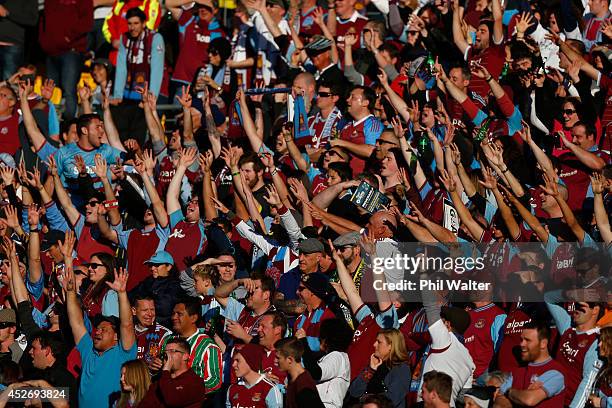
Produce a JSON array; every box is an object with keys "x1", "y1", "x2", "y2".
[{"x1": 423, "y1": 319, "x2": 476, "y2": 407}]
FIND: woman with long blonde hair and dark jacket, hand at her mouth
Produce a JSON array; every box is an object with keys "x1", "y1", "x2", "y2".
[{"x1": 349, "y1": 329, "x2": 412, "y2": 408}]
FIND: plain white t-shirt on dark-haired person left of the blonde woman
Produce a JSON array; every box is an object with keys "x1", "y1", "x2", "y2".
[{"x1": 317, "y1": 351, "x2": 351, "y2": 408}]
